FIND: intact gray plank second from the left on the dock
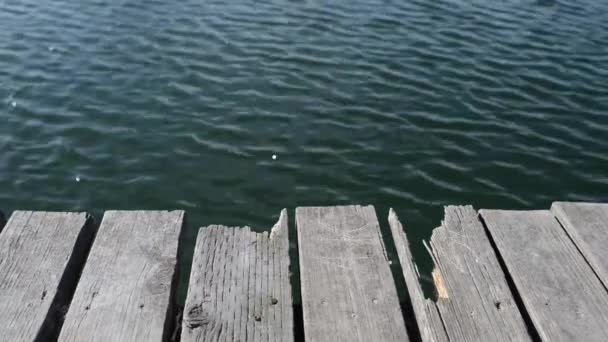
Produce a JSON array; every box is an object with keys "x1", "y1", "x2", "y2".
[{"x1": 59, "y1": 211, "x2": 184, "y2": 342}]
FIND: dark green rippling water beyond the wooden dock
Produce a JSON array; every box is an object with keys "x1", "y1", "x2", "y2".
[{"x1": 0, "y1": 0, "x2": 608, "y2": 302}]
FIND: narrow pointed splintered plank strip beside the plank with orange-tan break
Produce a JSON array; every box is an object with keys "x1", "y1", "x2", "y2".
[{"x1": 388, "y1": 209, "x2": 449, "y2": 342}]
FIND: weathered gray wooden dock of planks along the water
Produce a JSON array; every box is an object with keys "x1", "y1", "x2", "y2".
[{"x1": 0, "y1": 202, "x2": 608, "y2": 342}]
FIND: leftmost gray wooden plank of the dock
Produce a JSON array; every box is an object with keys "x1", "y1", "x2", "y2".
[{"x1": 0, "y1": 211, "x2": 95, "y2": 341}]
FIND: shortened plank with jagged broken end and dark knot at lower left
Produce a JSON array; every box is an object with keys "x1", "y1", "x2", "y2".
[{"x1": 181, "y1": 210, "x2": 294, "y2": 342}]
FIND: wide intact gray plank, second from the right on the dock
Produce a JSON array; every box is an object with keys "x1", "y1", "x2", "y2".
[{"x1": 480, "y1": 210, "x2": 608, "y2": 341}]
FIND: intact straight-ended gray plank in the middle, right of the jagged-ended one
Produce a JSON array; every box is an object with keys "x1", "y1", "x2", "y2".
[{"x1": 296, "y1": 206, "x2": 408, "y2": 342}]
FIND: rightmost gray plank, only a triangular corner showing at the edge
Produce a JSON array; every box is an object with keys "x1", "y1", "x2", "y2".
[{"x1": 551, "y1": 202, "x2": 608, "y2": 288}]
